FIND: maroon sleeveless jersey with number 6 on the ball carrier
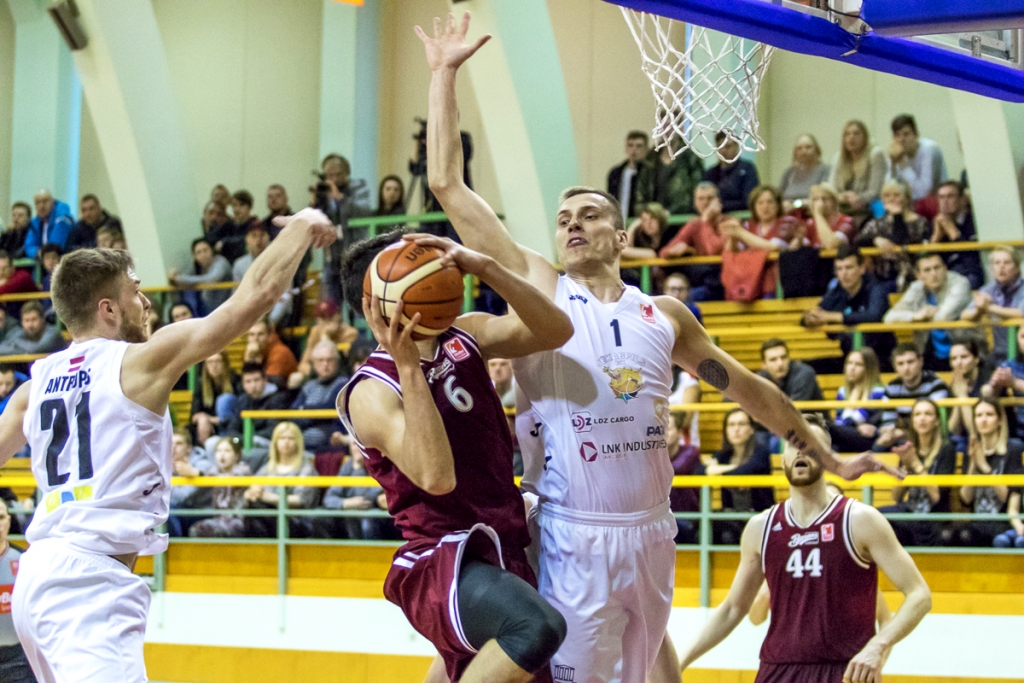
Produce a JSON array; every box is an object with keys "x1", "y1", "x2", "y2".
[{"x1": 341, "y1": 328, "x2": 529, "y2": 550}]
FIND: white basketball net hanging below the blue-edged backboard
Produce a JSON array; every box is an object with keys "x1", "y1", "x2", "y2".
[{"x1": 622, "y1": 7, "x2": 775, "y2": 162}]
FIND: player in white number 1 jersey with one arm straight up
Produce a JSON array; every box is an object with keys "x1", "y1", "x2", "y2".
[{"x1": 416, "y1": 14, "x2": 901, "y2": 683}]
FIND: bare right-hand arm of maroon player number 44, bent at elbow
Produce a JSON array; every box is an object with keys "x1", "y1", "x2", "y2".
[{"x1": 843, "y1": 504, "x2": 932, "y2": 681}]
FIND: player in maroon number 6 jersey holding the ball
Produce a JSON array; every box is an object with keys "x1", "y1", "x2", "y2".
[{"x1": 338, "y1": 232, "x2": 572, "y2": 681}]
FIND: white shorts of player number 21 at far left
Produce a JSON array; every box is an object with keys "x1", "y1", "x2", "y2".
[{"x1": 11, "y1": 540, "x2": 150, "y2": 683}]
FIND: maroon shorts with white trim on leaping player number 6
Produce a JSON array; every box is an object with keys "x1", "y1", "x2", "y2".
[{"x1": 384, "y1": 524, "x2": 551, "y2": 682}]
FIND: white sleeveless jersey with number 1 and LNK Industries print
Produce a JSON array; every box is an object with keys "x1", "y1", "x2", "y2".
[{"x1": 513, "y1": 275, "x2": 676, "y2": 513}]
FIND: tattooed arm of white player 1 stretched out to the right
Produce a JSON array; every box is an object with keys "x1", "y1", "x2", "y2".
[{"x1": 654, "y1": 296, "x2": 902, "y2": 480}]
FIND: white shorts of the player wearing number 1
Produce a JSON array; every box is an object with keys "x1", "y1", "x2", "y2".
[{"x1": 538, "y1": 502, "x2": 676, "y2": 683}]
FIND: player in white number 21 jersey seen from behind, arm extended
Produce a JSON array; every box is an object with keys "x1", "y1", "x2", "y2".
[{"x1": 0, "y1": 209, "x2": 335, "y2": 683}]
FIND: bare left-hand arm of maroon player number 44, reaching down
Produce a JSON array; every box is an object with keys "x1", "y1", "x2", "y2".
[{"x1": 679, "y1": 512, "x2": 768, "y2": 671}]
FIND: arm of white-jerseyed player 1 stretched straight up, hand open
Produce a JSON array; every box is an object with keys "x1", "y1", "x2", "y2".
[{"x1": 416, "y1": 12, "x2": 558, "y2": 296}]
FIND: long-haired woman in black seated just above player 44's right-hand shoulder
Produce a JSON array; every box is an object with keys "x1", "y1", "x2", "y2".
[{"x1": 882, "y1": 398, "x2": 956, "y2": 546}]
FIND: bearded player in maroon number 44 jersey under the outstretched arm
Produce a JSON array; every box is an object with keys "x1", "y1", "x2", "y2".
[{"x1": 681, "y1": 416, "x2": 932, "y2": 683}]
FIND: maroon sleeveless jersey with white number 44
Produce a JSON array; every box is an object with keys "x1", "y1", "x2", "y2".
[{"x1": 761, "y1": 496, "x2": 879, "y2": 664}]
